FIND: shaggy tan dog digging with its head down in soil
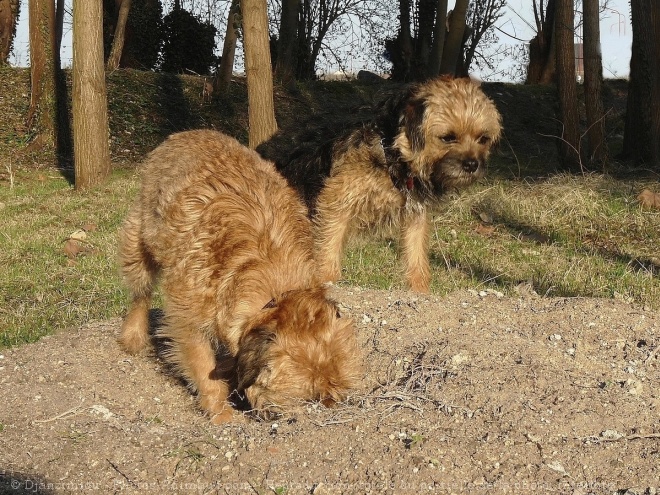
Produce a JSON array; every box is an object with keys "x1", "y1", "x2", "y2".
[{"x1": 120, "y1": 131, "x2": 360, "y2": 423}]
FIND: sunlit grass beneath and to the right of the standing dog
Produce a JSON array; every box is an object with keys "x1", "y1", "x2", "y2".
[{"x1": 343, "y1": 175, "x2": 660, "y2": 307}]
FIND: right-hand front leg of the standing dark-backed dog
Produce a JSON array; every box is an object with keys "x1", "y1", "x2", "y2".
[{"x1": 401, "y1": 210, "x2": 431, "y2": 293}]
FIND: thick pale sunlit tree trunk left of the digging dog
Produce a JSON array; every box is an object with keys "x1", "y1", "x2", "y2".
[{"x1": 73, "y1": 0, "x2": 110, "y2": 190}]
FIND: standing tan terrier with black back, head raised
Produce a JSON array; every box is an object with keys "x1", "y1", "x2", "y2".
[{"x1": 277, "y1": 77, "x2": 501, "y2": 292}]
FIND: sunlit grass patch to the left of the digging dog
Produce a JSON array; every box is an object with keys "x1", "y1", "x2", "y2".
[{"x1": 0, "y1": 171, "x2": 137, "y2": 347}]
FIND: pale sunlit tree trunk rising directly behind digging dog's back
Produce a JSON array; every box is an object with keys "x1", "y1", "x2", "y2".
[{"x1": 241, "y1": 0, "x2": 277, "y2": 149}]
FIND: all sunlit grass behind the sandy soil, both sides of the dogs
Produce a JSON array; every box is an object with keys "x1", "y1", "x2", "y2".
[{"x1": 0, "y1": 166, "x2": 660, "y2": 347}]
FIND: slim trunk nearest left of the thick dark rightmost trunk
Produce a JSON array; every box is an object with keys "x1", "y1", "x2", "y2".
[{"x1": 582, "y1": 0, "x2": 607, "y2": 169}]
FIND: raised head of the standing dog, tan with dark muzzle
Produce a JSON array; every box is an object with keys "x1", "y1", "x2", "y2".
[{"x1": 394, "y1": 77, "x2": 502, "y2": 195}]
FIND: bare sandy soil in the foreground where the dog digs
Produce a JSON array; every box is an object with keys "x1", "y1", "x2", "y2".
[{"x1": 0, "y1": 287, "x2": 660, "y2": 495}]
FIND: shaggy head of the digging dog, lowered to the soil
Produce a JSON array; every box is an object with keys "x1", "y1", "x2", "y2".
[{"x1": 236, "y1": 288, "x2": 361, "y2": 415}]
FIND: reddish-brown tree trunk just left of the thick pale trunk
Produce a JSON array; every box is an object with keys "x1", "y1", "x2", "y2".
[{"x1": 26, "y1": 0, "x2": 59, "y2": 153}]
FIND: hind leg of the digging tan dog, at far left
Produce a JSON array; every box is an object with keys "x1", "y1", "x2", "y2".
[{"x1": 119, "y1": 208, "x2": 158, "y2": 354}]
